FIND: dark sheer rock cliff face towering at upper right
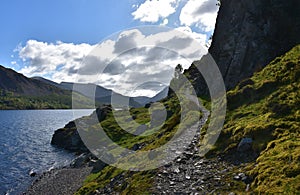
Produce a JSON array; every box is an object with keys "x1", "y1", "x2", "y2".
[{"x1": 209, "y1": 0, "x2": 300, "y2": 89}]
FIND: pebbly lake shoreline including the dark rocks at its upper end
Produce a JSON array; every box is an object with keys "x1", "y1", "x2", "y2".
[{"x1": 22, "y1": 153, "x2": 106, "y2": 195}]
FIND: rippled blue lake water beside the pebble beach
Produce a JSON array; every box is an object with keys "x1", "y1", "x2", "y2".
[{"x1": 0, "y1": 110, "x2": 93, "y2": 194}]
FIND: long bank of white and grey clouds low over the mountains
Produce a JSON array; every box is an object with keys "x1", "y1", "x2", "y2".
[{"x1": 19, "y1": 27, "x2": 206, "y2": 95}]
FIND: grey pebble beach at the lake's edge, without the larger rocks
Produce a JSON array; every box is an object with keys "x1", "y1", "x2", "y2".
[{"x1": 24, "y1": 167, "x2": 92, "y2": 195}]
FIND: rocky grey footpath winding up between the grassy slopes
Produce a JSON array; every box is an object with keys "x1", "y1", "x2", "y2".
[{"x1": 153, "y1": 94, "x2": 237, "y2": 194}]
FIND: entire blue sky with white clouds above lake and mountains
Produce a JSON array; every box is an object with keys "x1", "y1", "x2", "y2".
[{"x1": 0, "y1": 0, "x2": 218, "y2": 96}]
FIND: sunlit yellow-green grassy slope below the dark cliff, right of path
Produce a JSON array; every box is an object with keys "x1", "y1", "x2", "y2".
[{"x1": 216, "y1": 45, "x2": 300, "y2": 194}]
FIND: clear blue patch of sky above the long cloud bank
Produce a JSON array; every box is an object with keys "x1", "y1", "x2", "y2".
[{"x1": 0, "y1": 0, "x2": 139, "y2": 66}]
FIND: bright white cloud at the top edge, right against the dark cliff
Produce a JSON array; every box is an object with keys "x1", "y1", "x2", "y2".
[{"x1": 179, "y1": 0, "x2": 218, "y2": 32}]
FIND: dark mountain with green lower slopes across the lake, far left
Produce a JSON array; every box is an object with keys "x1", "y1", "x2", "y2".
[{"x1": 0, "y1": 65, "x2": 91, "y2": 109}]
